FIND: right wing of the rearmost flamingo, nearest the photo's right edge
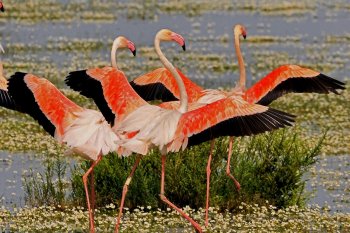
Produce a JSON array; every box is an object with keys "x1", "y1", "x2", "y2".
[{"x1": 245, "y1": 65, "x2": 345, "y2": 105}]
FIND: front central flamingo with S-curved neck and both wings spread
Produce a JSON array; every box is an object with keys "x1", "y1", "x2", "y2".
[{"x1": 66, "y1": 29, "x2": 293, "y2": 232}]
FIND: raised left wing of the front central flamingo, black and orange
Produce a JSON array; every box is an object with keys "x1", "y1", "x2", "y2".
[{"x1": 65, "y1": 67, "x2": 147, "y2": 125}]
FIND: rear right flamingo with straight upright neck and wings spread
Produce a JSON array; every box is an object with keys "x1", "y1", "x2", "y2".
[{"x1": 131, "y1": 25, "x2": 345, "y2": 225}]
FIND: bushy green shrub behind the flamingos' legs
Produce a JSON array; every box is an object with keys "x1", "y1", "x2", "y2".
[{"x1": 72, "y1": 130, "x2": 324, "y2": 210}]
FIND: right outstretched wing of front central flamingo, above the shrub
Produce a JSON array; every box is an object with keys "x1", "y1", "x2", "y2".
[{"x1": 170, "y1": 98, "x2": 294, "y2": 151}]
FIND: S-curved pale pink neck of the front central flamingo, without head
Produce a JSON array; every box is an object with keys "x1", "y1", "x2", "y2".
[{"x1": 154, "y1": 36, "x2": 188, "y2": 113}]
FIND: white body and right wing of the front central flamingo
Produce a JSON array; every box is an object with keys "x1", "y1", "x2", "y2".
[{"x1": 118, "y1": 95, "x2": 294, "y2": 154}]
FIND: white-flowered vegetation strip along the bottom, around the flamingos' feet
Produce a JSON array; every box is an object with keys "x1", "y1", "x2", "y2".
[{"x1": 0, "y1": 203, "x2": 350, "y2": 233}]
